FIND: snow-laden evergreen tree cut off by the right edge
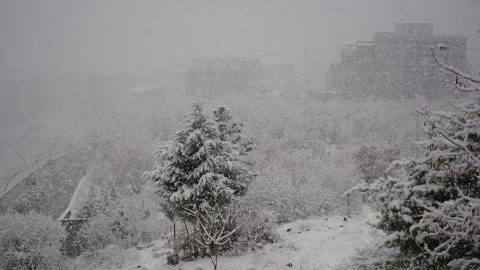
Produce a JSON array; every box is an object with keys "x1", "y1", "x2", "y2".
[{"x1": 348, "y1": 44, "x2": 480, "y2": 269}]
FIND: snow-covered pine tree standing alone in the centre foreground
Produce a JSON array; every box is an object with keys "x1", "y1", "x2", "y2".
[{"x1": 144, "y1": 99, "x2": 253, "y2": 222}]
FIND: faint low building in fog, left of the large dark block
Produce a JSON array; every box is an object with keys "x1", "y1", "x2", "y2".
[{"x1": 185, "y1": 56, "x2": 299, "y2": 96}]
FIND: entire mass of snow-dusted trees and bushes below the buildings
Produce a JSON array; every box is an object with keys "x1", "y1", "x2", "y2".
[{"x1": 0, "y1": 46, "x2": 479, "y2": 269}]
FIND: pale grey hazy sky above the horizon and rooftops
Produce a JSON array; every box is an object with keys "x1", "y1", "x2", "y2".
[{"x1": 0, "y1": 0, "x2": 480, "y2": 68}]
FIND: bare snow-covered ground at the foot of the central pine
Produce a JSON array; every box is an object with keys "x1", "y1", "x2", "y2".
[{"x1": 116, "y1": 207, "x2": 383, "y2": 270}]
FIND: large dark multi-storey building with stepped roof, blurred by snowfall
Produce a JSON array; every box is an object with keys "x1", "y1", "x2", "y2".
[{"x1": 327, "y1": 23, "x2": 467, "y2": 98}]
